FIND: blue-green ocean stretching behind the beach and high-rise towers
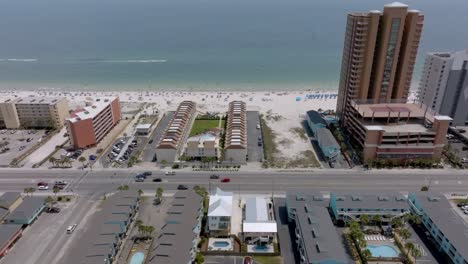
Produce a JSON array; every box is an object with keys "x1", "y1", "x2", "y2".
[{"x1": 0, "y1": 0, "x2": 468, "y2": 91}]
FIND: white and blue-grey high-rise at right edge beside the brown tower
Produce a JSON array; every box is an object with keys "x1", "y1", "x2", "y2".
[{"x1": 418, "y1": 50, "x2": 468, "y2": 126}]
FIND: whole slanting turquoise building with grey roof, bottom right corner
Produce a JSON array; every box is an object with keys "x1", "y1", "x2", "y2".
[{"x1": 408, "y1": 192, "x2": 468, "y2": 264}]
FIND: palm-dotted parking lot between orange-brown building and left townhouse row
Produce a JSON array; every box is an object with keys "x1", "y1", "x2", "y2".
[{"x1": 99, "y1": 137, "x2": 146, "y2": 168}]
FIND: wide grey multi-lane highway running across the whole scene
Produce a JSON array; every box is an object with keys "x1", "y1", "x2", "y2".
[{"x1": 0, "y1": 169, "x2": 468, "y2": 197}]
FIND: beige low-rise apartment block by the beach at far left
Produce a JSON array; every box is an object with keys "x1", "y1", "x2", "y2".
[{"x1": 0, "y1": 97, "x2": 69, "y2": 129}]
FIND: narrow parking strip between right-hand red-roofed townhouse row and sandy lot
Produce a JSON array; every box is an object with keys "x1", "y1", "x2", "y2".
[{"x1": 247, "y1": 111, "x2": 263, "y2": 162}]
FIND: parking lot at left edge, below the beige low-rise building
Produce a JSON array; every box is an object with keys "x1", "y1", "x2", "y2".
[{"x1": 0, "y1": 129, "x2": 49, "y2": 166}]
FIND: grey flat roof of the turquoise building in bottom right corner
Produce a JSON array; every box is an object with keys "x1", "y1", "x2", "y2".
[{"x1": 410, "y1": 192, "x2": 468, "y2": 260}]
